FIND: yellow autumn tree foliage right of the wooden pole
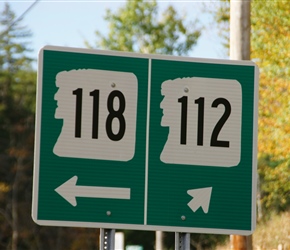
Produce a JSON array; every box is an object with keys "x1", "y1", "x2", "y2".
[{"x1": 251, "y1": 1, "x2": 290, "y2": 215}]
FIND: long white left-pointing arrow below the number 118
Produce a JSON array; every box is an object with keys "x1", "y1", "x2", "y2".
[{"x1": 55, "y1": 176, "x2": 130, "y2": 207}]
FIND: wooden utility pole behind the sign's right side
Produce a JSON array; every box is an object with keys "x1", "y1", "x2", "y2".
[{"x1": 230, "y1": 0, "x2": 252, "y2": 250}]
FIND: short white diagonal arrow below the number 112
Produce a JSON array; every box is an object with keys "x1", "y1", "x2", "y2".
[{"x1": 187, "y1": 187, "x2": 212, "y2": 214}]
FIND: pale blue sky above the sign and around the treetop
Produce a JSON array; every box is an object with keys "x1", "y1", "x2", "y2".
[{"x1": 0, "y1": 0, "x2": 227, "y2": 66}]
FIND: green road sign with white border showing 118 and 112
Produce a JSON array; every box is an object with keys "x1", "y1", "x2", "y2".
[{"x1": 32, "y1": 46, "x2": 258, "y2": 234}]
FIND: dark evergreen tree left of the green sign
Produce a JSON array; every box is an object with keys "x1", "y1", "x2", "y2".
[{"x1": 0, "y1": 4, "x2": 36, "y2": 249}]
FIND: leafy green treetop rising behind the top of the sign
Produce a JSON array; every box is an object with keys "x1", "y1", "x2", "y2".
[{"x1": 91, "y1": 0, "x2": 200, "y2": 55}]
